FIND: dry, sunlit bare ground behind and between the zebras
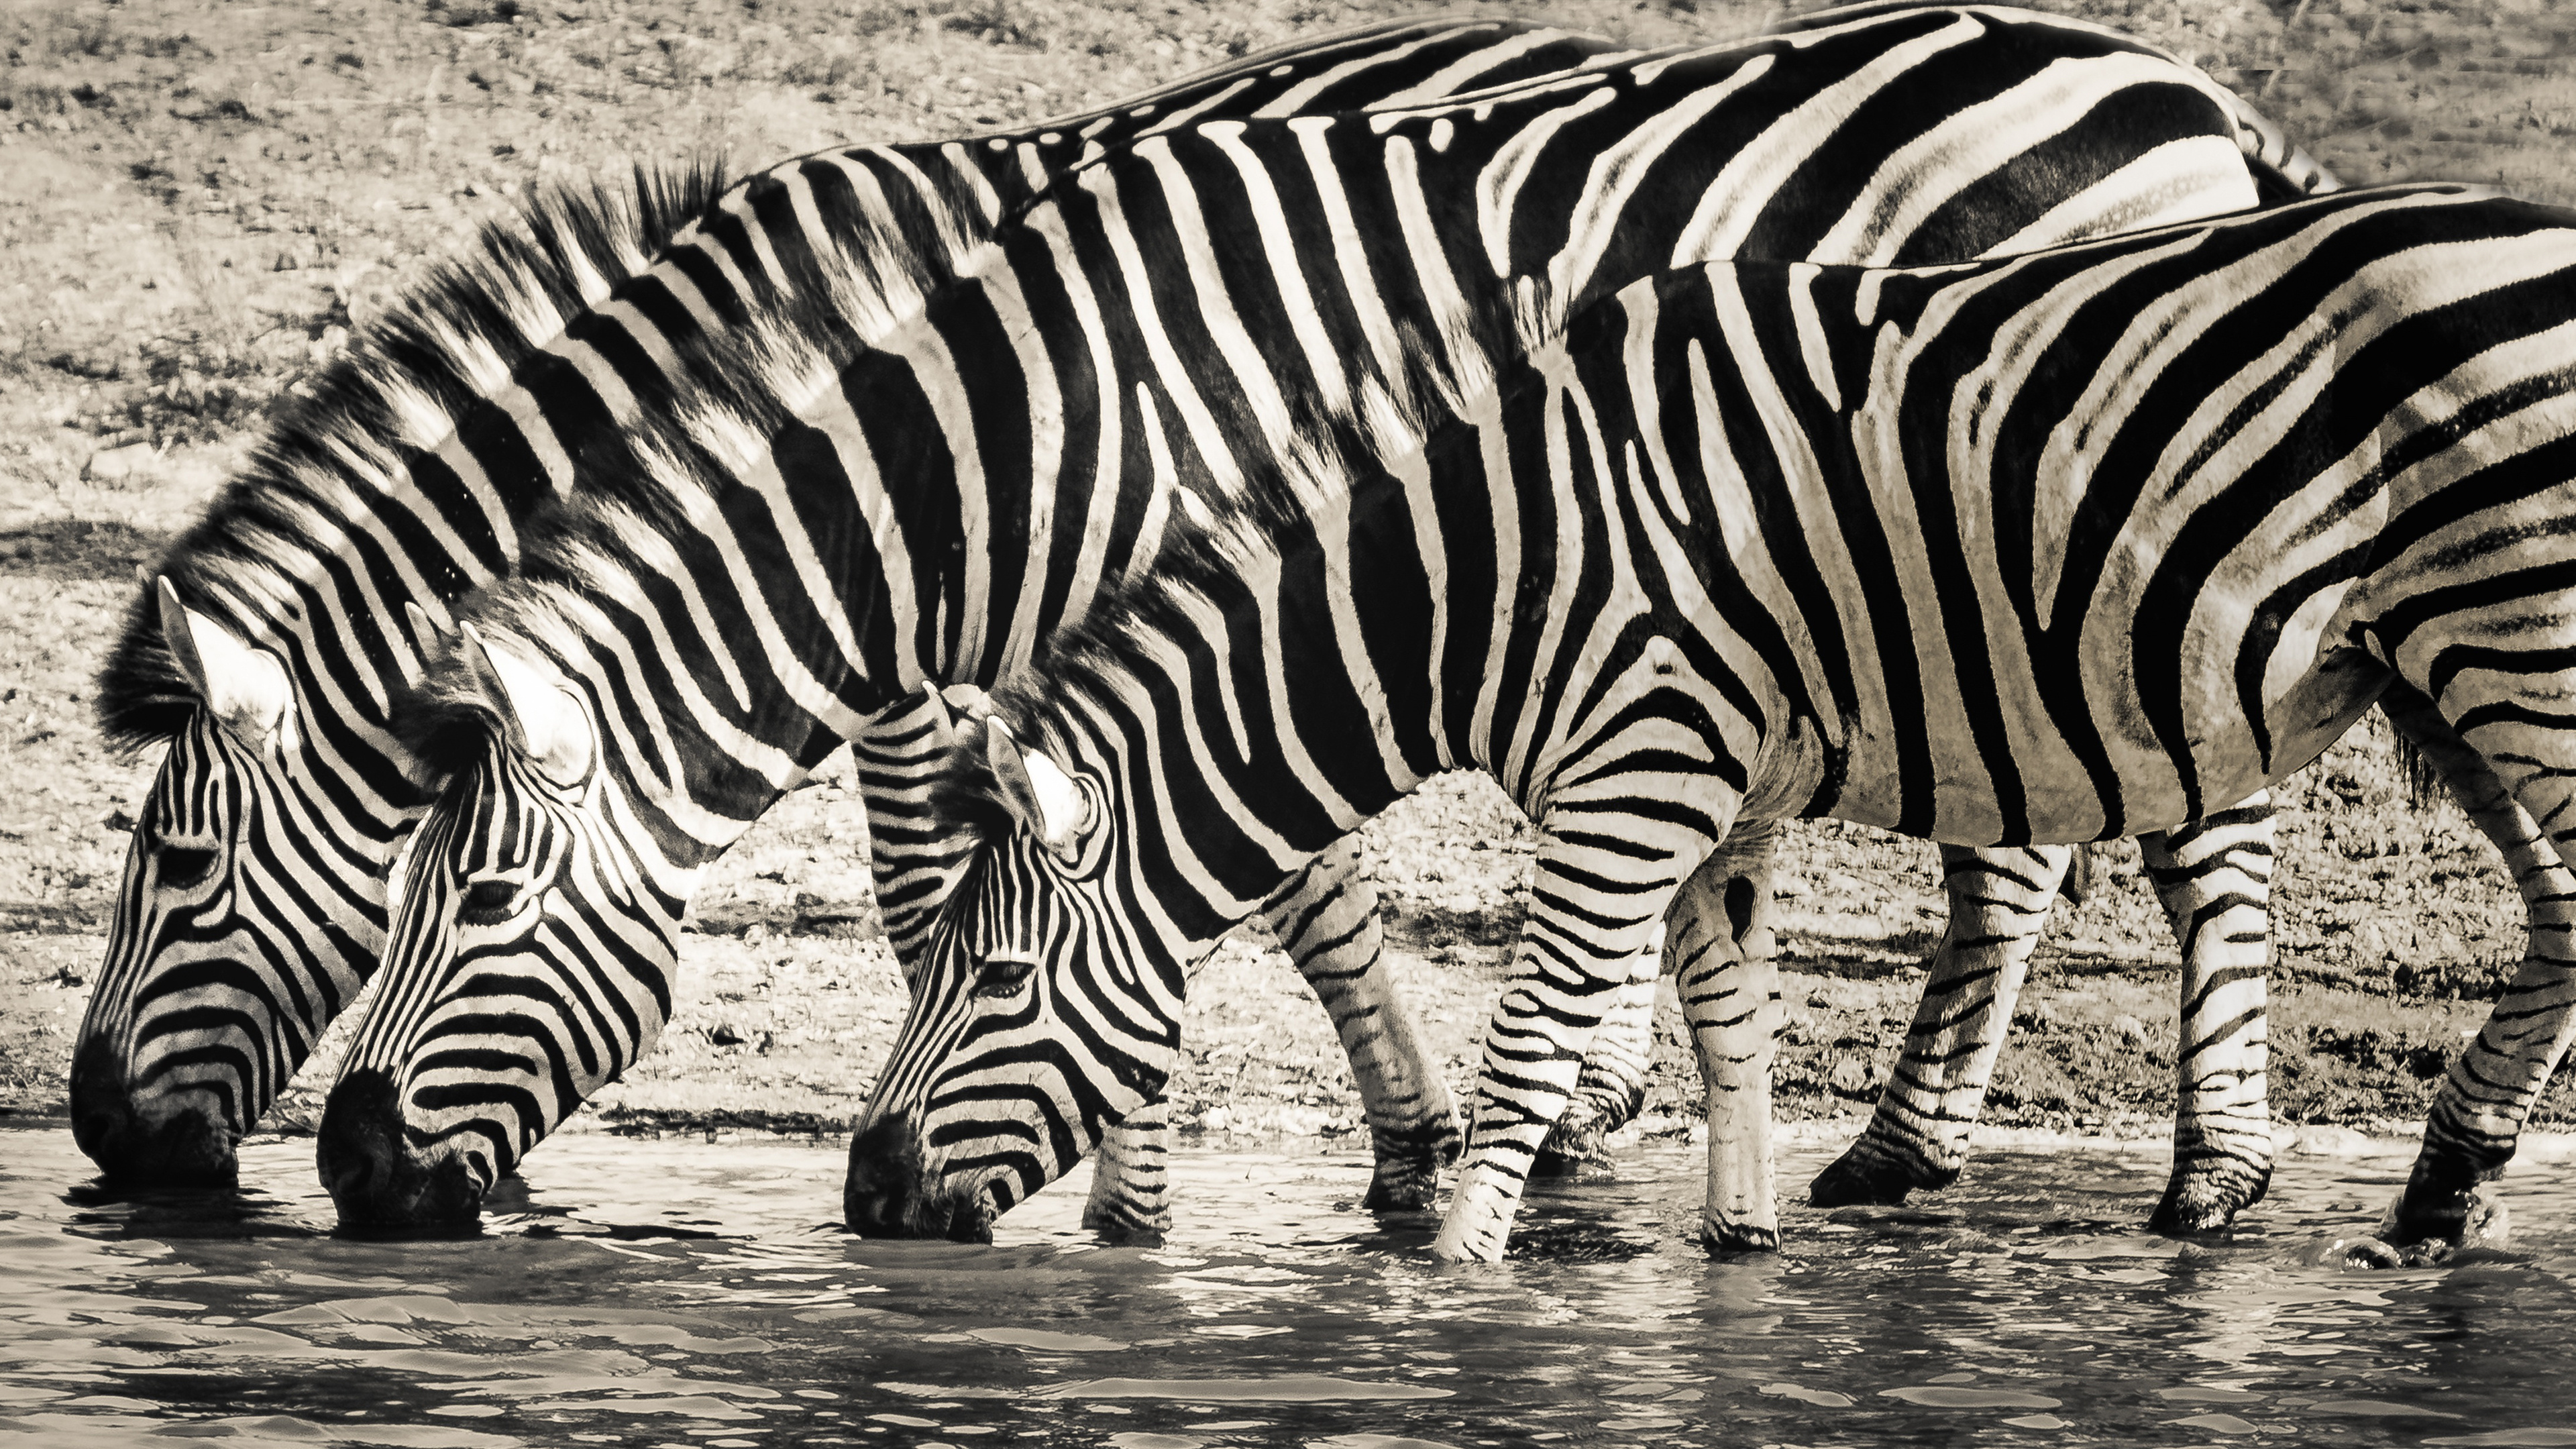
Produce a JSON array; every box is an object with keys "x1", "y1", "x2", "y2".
[{"x1": 0, "y1": 0, "x2": 2576, "y2": 1150}]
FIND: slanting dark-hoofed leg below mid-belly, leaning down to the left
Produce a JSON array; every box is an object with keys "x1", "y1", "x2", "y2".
[{"x1": 1809, "y1": 846, "x2": 2071, "y2": 1207}]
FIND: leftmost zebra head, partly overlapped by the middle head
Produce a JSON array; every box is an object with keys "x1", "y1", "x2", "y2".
[{"x1": 72, "y1": 578, "x2": 368, "y2": 1183}]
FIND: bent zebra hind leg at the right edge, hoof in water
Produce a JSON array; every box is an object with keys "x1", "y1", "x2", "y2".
[{"x1": 2380, "y1": 686, "x2": 2576, "y2": 1245}]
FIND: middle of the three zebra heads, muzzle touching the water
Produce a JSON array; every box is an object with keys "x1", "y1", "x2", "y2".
[{"x1": 317, "y1": 627, "x2": 685, "y2": 1225}]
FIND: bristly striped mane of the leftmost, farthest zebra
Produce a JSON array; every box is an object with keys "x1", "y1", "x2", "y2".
[{"x1": 98, "y1": 157, "x2": 729, "y2": 750}]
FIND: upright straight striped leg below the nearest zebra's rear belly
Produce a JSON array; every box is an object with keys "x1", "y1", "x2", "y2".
[{"x1": 2138, "y1": 792, "x2": 2272, "y2": 1235}]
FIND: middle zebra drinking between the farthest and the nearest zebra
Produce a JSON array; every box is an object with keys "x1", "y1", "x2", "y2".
[{"x1": 319, "y1": 8, "x2": 2349, "y2": 1222}]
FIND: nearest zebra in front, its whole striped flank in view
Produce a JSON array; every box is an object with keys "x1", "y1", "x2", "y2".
[{"x1": 847, "y1": 186, "x2": 2576, "y2": 1260}]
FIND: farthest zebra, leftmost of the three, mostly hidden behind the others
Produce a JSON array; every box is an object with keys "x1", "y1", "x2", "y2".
[{"x1": 72, "y1": 21, "x2": 1613, "y2": 1181}]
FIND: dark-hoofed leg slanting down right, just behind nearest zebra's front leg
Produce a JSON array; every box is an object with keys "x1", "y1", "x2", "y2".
[{"x1": 1256, "y1": 835, "x2": 1458, "y2": 1212}]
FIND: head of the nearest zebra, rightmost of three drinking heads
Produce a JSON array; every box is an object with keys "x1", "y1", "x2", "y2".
[{"x1": 843, "y1": 719, "x2": 1195, "y2": 1240}]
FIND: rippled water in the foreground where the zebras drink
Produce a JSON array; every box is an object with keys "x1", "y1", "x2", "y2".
[{"x1": 0, "y1": 1129, "x2": 2576, "y2": 1449}]
